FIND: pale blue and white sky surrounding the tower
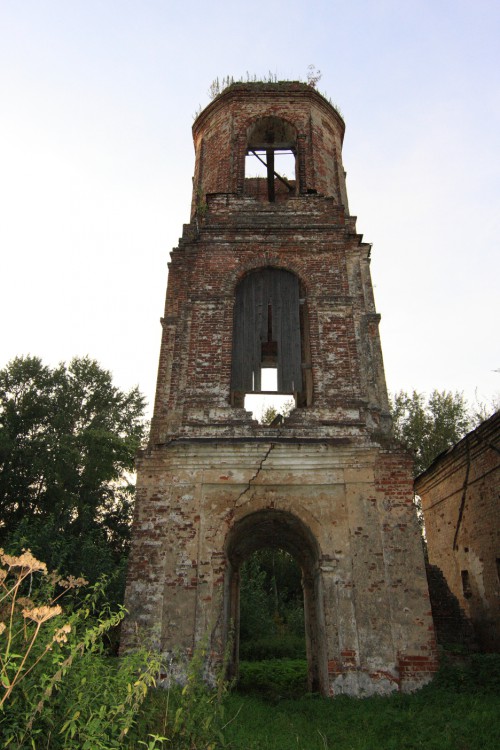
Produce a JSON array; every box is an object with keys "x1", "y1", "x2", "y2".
[{"x1": 0, "y1": 0, "x2": 500, "y2": 414}]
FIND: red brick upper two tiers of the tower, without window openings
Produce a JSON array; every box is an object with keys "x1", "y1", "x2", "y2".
[{"x1": 153, "y1": 83, "x2": 389, "y2": 441}]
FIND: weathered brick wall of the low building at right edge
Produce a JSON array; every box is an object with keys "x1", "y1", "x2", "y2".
[{"x1": 415, "y1": 412, "x2": 500, "y2": 651}]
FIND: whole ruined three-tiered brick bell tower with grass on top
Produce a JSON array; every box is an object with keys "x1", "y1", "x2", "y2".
[{"x1": 123, "y1": 82, "x2": 437, "y2": 695}]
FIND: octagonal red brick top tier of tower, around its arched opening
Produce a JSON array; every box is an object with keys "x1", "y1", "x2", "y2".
[{"x1": 192, "y1": 82, "x2": 347, "y2": 214}]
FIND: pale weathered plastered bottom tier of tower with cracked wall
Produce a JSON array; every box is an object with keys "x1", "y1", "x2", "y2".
[{"x1": 122, "y1": 438, "x2": 437, "y2": 696}]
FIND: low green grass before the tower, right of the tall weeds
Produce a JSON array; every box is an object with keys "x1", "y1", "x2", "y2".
[{"x1": 224, "y1": 668, "x2": 500, "y2": 750}]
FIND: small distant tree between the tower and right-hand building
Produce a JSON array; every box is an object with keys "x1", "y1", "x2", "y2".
[{"x1": 391, "y1": 391, "x2": 474, "y2": 476}]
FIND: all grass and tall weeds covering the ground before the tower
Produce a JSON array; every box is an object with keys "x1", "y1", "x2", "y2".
[{"x1": 0, "y1": 552, "x2": 500, "y2": 750}]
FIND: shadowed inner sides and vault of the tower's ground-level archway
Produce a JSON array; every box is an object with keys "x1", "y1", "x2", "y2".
[{"x1": 224, "y1": 509, "x2": 328, "y2": 695}]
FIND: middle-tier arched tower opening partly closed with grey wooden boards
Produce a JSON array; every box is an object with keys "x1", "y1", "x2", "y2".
[{"x1": 231, "y1": 268, "x2": 312, "y2": 414}]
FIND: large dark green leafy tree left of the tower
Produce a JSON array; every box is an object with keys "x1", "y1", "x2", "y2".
[{"x1": 0, "y1": 357, "x2": 145, "y2": 596}]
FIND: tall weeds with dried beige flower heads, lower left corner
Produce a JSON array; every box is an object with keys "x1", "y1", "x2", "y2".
[{"x1": 0, "y1": 550, "x2": 159, "y2": 750}]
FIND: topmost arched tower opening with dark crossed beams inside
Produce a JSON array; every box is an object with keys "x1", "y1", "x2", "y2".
[{"x1": 245, "y1": 117, "x2": 297, "y2": 203}]
